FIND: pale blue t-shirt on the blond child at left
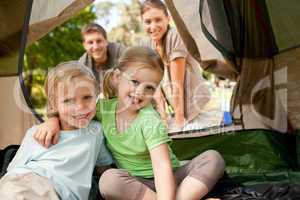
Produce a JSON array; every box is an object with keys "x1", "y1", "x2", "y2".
[{"x1": 7, "y1": 121, "x2": 113, "y2": 199}]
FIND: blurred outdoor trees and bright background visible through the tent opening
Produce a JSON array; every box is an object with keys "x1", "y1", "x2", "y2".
[{"x1": 24, "y1": 0, "x2": 231, "y2": 119}]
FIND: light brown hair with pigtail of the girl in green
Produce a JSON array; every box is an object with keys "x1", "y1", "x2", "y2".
[{"x1": 103, "y1": 46, "x2": 164, "y2": 98}]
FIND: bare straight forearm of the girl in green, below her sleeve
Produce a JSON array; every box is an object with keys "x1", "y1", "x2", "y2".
[{"x1": 150, "y1": 144, "x2": 176, "y2": 200}]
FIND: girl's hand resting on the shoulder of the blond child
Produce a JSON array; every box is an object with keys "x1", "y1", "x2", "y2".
[{"x1": 33, "y1": 117, "x2": 60, "y2": 148}]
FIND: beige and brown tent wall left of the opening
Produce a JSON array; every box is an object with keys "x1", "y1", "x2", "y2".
[{"x1": 0, "y1": 0, "x2": 93, "y2": 148}]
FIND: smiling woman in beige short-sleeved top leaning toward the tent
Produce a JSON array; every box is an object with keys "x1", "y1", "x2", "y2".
[{"x1": 141, "y1": 0, "x2": 210, "y2": 130}]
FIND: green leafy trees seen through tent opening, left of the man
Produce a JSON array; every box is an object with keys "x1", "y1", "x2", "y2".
[{"x1": 24, "y1": 6, "x2": 96, "y2": 111}]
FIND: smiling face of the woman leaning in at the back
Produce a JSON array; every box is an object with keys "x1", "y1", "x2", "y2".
[{"x1": 142, "y1": 8, "x2": 170, "y2": 43}]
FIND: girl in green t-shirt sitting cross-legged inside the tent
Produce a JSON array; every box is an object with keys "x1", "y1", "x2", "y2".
[{"x1": 34, "y1": 47, "x2": 224, "y2": 200}]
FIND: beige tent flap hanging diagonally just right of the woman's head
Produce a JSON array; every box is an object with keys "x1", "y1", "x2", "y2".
[{"x1": 165, "y1": 0, "x2": 238, "y2": 80}]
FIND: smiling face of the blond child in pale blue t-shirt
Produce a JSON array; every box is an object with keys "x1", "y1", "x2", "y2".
[{"x1": 56, "y1": 77, "x2": 96, "y2": 130}]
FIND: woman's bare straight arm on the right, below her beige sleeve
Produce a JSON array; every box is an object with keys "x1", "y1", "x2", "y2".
[{"x1": 170, "y1": 58, "x2": 186, "y2": 127}]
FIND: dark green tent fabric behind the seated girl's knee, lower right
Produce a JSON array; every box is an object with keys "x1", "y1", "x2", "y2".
[{"x1": 171, "y1": 129, "x2": 300, "y2": 185}]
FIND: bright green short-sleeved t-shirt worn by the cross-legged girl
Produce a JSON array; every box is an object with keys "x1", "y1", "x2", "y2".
[{"x1": 96, "y1": 99, "x2": 179, "y2": 178}]
